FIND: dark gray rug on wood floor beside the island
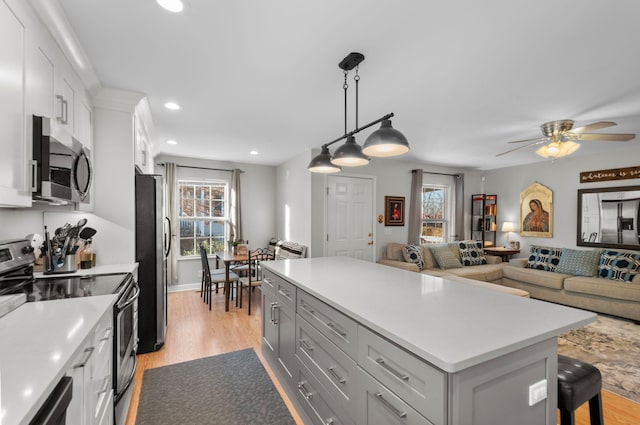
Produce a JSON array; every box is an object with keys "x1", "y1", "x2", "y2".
[{"x1": 136, "y1": 349, "x2": 295, "y2": 425}]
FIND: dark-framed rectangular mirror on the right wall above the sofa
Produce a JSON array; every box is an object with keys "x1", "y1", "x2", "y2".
[{"x1": 576, "y1": 186, "x2": 640, "y2": 250}]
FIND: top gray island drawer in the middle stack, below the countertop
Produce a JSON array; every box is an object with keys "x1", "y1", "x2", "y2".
[{"x1": 297, "y1": 291, "x2": 358, "y2": 359}]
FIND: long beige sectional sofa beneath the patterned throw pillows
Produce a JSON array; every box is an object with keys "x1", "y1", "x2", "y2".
[{"x1": 378, "y1": 243, "x2": 640, "y2": 322}]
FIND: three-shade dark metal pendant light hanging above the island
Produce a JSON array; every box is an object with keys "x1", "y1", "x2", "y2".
[{"x1": 307, "y1": 52, "x2": 409, "y2": 173}]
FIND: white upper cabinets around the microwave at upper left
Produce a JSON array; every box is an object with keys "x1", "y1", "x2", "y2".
[{"x1": 0, "y1": 0, "x2": 93, "y2": 207}]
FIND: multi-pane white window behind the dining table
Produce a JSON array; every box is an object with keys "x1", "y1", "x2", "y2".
[{"x1": 178, "y1": 180, "x2": 228, "y2": 257}]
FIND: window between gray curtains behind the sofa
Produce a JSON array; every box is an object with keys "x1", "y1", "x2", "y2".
[{"x1": 420, "y1": 185, "x2": 450, "y2": 244}]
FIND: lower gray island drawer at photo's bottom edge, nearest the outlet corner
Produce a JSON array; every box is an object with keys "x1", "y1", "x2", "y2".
[{"x1": 358, "y1": 369, "x2": 434, "y2": 425}]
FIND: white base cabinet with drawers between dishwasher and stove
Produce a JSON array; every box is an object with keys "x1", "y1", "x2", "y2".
[{"x1": 66, "y1": 304, "x2": 113, "y2": 425}]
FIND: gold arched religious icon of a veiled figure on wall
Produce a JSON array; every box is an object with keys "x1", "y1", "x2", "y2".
[{"x1": 520, "y1": 182, "x2": 553, "y2": 238}]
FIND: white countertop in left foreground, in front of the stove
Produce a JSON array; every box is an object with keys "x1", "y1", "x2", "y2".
[{"x1": 0, "y1": 295, "x2": 116, "y2": 425}]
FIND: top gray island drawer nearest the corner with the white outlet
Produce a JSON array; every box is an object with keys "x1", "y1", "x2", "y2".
[{"x1": 357, "y1": 326, "x2": 447, "y2": 425}]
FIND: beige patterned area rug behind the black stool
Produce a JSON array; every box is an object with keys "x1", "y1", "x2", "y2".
[{"x1": 558, "y1": 315, "x2": 640, "y2": 403}]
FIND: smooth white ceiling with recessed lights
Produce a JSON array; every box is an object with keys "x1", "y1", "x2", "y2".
[{"x1": 53, "y1": 0, "x2": 640, "y2": 169}]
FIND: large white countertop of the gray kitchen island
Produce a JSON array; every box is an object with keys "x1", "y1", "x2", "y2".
[{"x1": 262, "y1": 257, "x2": 596, "y2": 372}]
